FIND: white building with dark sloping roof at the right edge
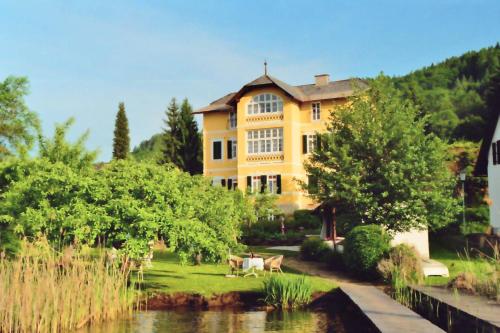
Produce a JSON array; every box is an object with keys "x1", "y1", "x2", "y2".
[{"x1": 474, "y1": 109, "x2": 500, "y2": 235}]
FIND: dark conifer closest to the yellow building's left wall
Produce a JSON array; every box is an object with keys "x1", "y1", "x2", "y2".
[{"x1": 179, "y1": 98, "x2": 203, "y2": 175}]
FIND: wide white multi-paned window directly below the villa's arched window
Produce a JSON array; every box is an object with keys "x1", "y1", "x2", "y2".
[{"x1": 247, "y1": 128, "x2": 283, "y2": 154}]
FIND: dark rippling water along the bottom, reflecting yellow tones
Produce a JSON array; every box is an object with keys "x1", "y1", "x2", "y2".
[{"x1": 78, "y1": 309, "x2": 344, "y2": 333}]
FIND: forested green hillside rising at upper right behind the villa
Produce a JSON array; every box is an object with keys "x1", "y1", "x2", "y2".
[{"x1": 394, "y1": 43, "x2": 500, "y2": 141}]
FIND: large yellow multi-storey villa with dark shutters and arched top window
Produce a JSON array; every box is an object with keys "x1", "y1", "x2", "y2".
[{"x1": 195, "y1": 73, "x2": 363, "y2": 213}]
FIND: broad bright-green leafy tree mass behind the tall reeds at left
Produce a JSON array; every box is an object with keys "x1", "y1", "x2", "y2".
[{"x1": 0, "y1": 158, "x2": 248, "y2": 262}]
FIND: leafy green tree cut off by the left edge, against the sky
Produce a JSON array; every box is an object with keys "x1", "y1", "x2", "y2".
[{"x1": 0, "y1": 76, "x2": 38, "y2": 158}]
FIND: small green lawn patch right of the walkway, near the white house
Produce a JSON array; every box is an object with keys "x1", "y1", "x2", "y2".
[{"x1": 425, "y1": 243, "x2": 490, "y2": 285}]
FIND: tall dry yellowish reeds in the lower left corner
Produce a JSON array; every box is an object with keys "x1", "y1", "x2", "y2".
[{"x1": 0, "y1": 241, "x2": 135, "y2": 332}]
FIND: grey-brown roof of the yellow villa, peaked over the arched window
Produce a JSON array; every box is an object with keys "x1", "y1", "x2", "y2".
[{"x1": 193, "y1": 74, "x2": 368, "y2": 113}]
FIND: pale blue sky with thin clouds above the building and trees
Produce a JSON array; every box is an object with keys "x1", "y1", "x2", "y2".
[{"x1": 0, "y1": 0, "x2": 500, "y2": 160}]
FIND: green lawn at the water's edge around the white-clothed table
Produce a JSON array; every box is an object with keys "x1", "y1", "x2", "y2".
[{"x1": 139, "y1": 247, "x2": 336, "y2": 296}]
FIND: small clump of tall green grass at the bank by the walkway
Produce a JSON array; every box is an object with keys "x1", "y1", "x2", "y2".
[{"x1": 264, "y1": 275, "x2": 312, "y2": 308}]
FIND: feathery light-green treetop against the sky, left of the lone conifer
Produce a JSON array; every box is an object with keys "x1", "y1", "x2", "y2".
[{"x1": 38, "y1": 118, "x2": 98, "y2": 170}]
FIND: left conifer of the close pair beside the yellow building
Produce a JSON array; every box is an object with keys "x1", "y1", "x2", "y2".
[{"x1": 161, "y1": 98, "x2": 184, "y2": 169}]
